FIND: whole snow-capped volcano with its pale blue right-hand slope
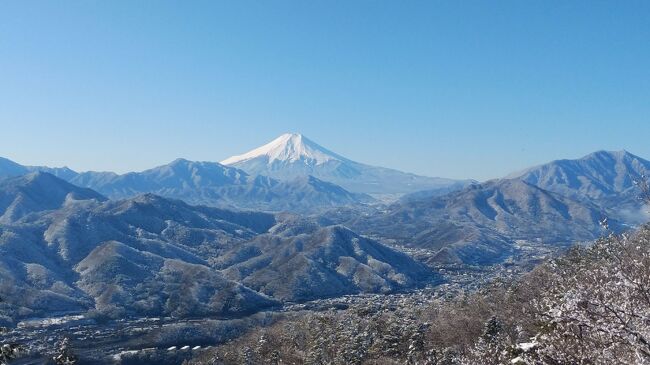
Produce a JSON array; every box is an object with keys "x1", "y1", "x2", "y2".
[{"x1": 221, "y1": 134, "x2": 469, "y2": 195}]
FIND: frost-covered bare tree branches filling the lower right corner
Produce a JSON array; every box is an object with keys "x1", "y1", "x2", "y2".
[{"x1": 535, "y1": 227, "x2": 650, "y2": 365}]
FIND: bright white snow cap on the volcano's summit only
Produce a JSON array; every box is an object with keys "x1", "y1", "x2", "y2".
[{"x1": 221, "y1": 133, "x2": 345, "y2": 165}]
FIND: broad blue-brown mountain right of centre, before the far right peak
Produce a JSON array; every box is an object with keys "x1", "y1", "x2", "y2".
[{"x1": 322, "y1": 179, "x2": 616, "y2": 264}]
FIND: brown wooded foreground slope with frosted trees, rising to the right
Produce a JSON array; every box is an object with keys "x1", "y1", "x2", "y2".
[{"x1": 188, "y1": 222, "x2": 650, "y2": 365}]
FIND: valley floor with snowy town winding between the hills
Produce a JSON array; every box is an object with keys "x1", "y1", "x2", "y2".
[{"x1": 0, "y1": 237, "x2": 557, "y2": 365}]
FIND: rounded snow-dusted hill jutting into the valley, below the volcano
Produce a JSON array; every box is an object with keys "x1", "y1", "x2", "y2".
[{"x1": 216, "y1": 226, "x2": 436, "y2": 301}]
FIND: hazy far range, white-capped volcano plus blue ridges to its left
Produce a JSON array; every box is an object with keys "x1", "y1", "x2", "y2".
[{"x1": 0, "y1": 134, "x2": 471, "y2": 213}]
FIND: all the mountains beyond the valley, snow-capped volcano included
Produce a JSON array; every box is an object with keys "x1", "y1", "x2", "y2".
[{"x1": 0, "y1": 134, "x2": 650, "y2": 323}]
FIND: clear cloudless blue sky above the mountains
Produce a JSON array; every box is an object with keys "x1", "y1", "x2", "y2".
[{"x1": 0, "y1": 0, "x2": 650, "y2": 179}]
